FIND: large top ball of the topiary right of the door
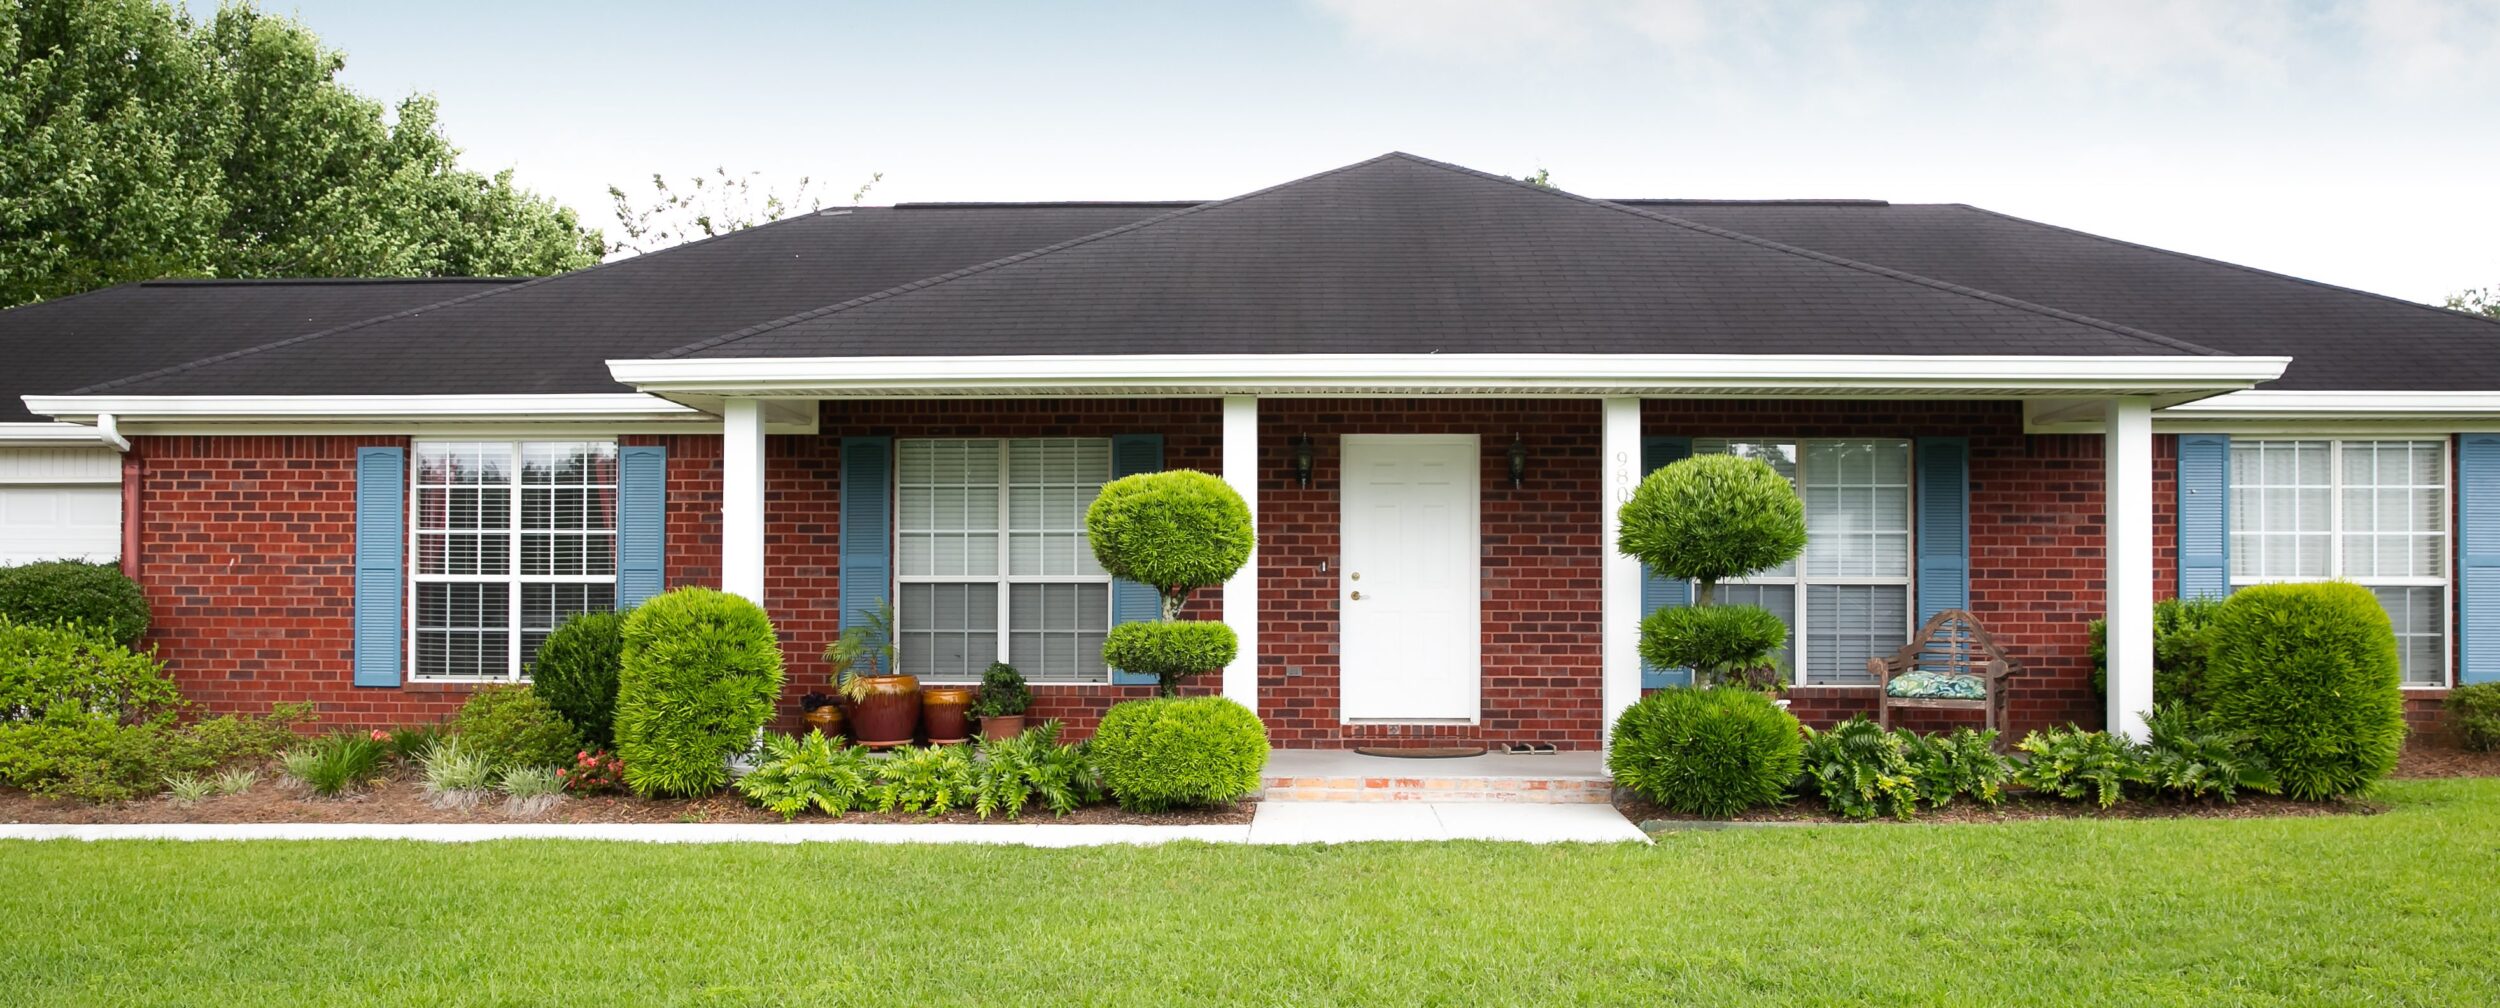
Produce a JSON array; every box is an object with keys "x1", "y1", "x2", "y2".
[{"x1": 1615, "y1": 455, "x2": 1805, "y2": 592}]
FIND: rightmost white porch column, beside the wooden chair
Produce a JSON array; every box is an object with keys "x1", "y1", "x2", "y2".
[{"x1": 2103, "y1": 398, "x2": 2153, "y2": 740}]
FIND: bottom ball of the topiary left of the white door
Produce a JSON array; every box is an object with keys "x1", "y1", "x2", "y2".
[{"x1": 1085, "y1": 695, "x2": 1268, "y2": 813}]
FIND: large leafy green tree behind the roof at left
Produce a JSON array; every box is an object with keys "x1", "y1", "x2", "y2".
[{"x1": 0, "y1": 0, "x2": 605, "y2": 305}]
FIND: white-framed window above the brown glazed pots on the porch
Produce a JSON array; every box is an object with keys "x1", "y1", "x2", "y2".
[{"x1": 895, "y1": 438, "x2": 1110, "y2": 683}]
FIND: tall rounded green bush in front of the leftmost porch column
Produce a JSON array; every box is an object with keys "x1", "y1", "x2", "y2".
[{"x1": 615, "y1": 588, "x2": 783, "y2": 798}]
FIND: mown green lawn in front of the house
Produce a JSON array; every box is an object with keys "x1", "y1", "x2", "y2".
[{"x1": 0, "y1": 780, "x2": 2500, "y2": 1008}]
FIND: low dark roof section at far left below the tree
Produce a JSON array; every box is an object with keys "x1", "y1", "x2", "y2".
[{"x1": 0, "y1": 278, "x2": 513, "y2": 423}]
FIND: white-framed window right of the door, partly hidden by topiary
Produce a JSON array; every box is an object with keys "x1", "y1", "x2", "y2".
[{"x1": 1693, "y1": 438, "x2": 1913, "y2": 685}]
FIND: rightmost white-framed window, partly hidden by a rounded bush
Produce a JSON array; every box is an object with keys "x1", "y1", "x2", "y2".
[{"x1": 2230, "y1": 438, "x2": 2450, "y2": 688}]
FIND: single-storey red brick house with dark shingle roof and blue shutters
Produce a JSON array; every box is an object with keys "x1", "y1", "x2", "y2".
[{"x1": 14, "y1": 155, "x2": 2500, "y2": 748}]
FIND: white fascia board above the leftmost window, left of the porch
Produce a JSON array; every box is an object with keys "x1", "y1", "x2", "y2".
[{"x1": 25, "y1": 393, "x2": 705, "y2": 425}]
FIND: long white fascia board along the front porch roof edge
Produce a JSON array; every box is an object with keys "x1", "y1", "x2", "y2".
[{"x1": 608, "y1": 353, "x2": 2290, "y2": 398}]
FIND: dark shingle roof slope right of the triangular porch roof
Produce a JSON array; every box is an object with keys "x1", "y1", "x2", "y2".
[{"x1": 1620, "y1": 200, "x2": 2500, "y2": 393}]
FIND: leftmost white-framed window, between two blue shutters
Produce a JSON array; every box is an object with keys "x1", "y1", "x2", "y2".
[{"x1": 408, "y1": 440, "x2": 618, "y2": 683}]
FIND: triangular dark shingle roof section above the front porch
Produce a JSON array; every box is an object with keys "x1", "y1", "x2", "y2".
[{"x1": 680, "y1": 155, "x2": 2213, "y2": 358}]
